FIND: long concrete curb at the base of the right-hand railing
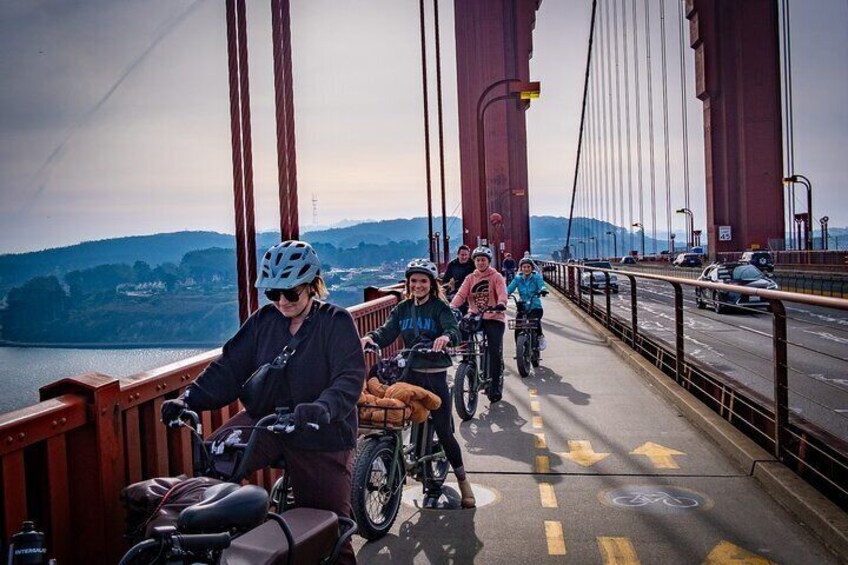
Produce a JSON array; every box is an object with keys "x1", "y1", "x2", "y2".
[{"x1": 556, "y1": 294, "x2": 848, "y2": 559}]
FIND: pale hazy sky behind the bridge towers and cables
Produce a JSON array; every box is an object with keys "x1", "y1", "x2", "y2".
[{"x1": 0, "y1": 0, "x2": 848, "y2": 253}]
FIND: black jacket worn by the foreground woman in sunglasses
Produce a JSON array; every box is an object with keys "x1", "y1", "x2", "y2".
[{"x1": 183, "y1": 302, "x2": 365, "y2": 451}]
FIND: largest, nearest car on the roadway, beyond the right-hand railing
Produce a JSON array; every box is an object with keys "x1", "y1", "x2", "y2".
[{"x1": 695, "y1": 262, "x2": 778, "y2": 314}]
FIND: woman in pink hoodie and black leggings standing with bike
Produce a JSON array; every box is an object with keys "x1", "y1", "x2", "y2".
[{"x1": 451, "y1": 246, "x2": 507, "y2": 402}]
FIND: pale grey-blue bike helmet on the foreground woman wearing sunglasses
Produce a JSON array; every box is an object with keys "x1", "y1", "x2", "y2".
[{"x1": 256, "y1": 240, "x2": 321, "y2": 290}]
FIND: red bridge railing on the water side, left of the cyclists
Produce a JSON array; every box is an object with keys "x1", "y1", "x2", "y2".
[{"x1": 0, "y1": 288, "x2": 398, "y2": 563}]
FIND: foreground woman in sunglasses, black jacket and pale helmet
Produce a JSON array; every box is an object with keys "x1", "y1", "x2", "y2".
[{"x1": 162, "y1": 241, "x2": 365, "y2": 563}]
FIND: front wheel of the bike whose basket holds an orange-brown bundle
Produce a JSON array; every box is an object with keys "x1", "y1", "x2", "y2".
[{"x1": 350, "y1": 436, "x2": 403, "y2": 540}]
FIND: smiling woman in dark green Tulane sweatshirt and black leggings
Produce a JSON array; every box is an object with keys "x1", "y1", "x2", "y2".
[{"x1": 362, "y1": 259, "x2": 476, "y2": 508}]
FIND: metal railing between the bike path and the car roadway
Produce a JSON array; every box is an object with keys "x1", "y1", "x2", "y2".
[{"x1": 539, "y1": 262, "x2": 848, "y2": 508}]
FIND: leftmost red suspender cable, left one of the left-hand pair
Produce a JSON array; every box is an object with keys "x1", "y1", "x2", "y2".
[{"x1": 226, "y1": 0, "x2": 250, "y2": 323}]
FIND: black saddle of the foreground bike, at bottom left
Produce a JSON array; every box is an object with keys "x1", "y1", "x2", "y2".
[{"x1": 177, "y1": 483, "x2": 268, "y2": 533}]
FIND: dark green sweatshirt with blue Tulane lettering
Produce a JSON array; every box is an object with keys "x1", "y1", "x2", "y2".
[{"x1": 368, "y1": 296, "x2": 459, "y2": 369}]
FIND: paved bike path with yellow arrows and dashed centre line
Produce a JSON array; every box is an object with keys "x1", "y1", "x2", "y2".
[{"x1": 355, "y1": 297, "x2": 839, "y2": 565}]
